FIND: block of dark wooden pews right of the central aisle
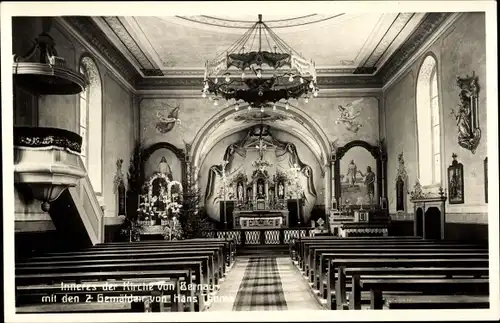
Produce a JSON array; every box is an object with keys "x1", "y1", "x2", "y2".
[{"x1": 290, "y1": 236, "x2": 489, "y2": 310}]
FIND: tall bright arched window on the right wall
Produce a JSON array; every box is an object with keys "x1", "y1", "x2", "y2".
[{"x1": 416, "y1": 56, "x2": 441, "y2": 185}]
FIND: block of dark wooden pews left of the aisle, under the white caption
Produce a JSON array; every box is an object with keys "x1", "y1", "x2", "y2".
[{"x1": 15, "y1": 239, "x2": 236, "y2": 313}]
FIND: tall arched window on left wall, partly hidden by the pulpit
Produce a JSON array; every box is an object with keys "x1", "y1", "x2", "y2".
[{"x1": 80, "y1": 56, "x2": 102, "y2": 193}]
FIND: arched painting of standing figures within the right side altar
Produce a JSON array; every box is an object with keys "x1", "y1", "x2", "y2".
[{"x1": 340, "y1": 147, "x2": 378, "y2": 205}]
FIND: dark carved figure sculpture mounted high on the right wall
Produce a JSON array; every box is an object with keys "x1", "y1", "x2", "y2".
[{"x1": 451, "y1": 72, "x2": 481, "y2": 154}]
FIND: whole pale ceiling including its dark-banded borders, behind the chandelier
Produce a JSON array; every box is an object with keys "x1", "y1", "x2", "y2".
[{"x1": 60, "y1": 12, "x2": 449, "y2": 90}]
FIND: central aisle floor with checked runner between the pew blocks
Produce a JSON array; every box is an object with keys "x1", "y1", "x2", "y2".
[{"x1": 208, "y1": 256, "x2": 322, "y2": 312}]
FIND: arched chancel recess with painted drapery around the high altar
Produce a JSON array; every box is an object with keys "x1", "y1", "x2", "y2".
[{"x1": 198, "y1": 124, "x2": 325, "y2": 225}]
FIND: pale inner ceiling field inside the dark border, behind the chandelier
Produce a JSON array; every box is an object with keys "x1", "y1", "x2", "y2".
[{"x1": 93, "y1": 12, "x2": 425, "y2": 76}]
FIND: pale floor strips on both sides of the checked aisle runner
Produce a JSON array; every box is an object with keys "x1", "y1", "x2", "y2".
[{"x1": 208, "y1": 257, "x2": 322, "y2": 312}]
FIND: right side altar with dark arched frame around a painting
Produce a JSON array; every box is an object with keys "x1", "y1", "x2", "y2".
[{"x1": 328, "y1": 140, "x2": 391, "y2": 237}]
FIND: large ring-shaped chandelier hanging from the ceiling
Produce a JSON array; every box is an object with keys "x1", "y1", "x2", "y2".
[{"x1": 202, "y1": 15, "x2": 318, "y2": 110}]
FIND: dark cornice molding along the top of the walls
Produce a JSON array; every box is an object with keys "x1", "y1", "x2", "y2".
[{"x1": 57, "y1": 13, "x2": 453, "y2": 93}]
